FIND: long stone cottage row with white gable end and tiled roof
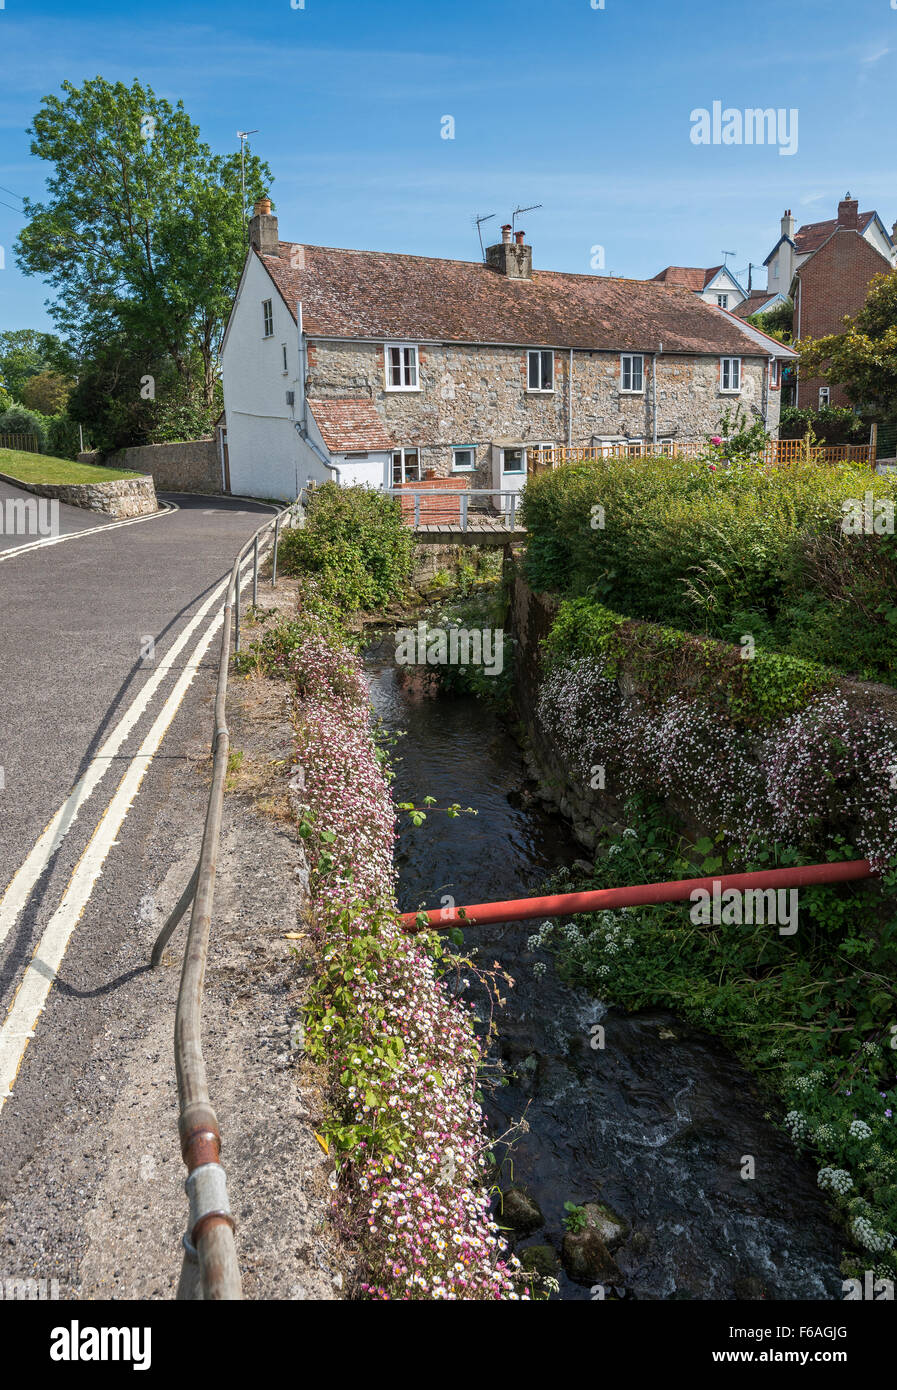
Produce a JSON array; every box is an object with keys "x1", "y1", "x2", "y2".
[{"x1": 223, "y1": 200, "x2": 794, "y2": 498}]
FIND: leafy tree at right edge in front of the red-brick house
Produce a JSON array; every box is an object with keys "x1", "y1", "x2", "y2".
[{"x1": 797, "y1": 271, "x2": 897, "y2": 418}]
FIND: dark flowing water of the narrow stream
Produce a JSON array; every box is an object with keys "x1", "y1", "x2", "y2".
[{"x1": 367, "y1": 638, "x2": 843, "y2": 1300}]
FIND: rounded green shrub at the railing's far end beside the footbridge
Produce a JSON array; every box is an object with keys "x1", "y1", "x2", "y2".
[{"x1": 278, "y1": 482, "x2": 414, "y2": 613}]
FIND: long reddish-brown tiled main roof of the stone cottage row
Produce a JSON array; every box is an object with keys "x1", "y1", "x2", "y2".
[{"x1": 260, "y1": 242, "x2": 762, "y2": 354}]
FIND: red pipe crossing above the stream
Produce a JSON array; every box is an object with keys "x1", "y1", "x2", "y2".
[{"x1": 401, "y1": 859, "x2": 872, "y2": 931}]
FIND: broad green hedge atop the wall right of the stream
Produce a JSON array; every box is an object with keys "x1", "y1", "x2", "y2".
[{"x1": 523, "y1": 459, "x2": 897, "y2": 682}]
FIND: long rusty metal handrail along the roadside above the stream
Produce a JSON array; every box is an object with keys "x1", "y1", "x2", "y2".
[{"x1": 150, "y1": 498, "x2": 302, "y2": 1301}]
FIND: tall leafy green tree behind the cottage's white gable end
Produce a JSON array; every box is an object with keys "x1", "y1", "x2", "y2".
[{"x1": 17, "y1": 78, "x2": 271, "y2": 406}]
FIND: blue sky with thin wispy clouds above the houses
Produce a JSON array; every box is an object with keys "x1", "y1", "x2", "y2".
[{"x1": 0, "y1": 0, "x2": 897, "y2": 329}]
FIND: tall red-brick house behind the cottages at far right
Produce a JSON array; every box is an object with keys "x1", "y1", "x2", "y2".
[{"x1": 763, "y1": 193, "x2": 897, "y2": 410}]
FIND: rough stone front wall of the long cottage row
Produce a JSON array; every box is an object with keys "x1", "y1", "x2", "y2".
[{"x1": 307, "y1": 341, "x2": 779, "y2": 487}]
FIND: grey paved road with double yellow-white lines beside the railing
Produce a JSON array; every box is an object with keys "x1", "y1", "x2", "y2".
[{"x1": 0, "y1": 496, "x2": 278, "y2": 1275}]
